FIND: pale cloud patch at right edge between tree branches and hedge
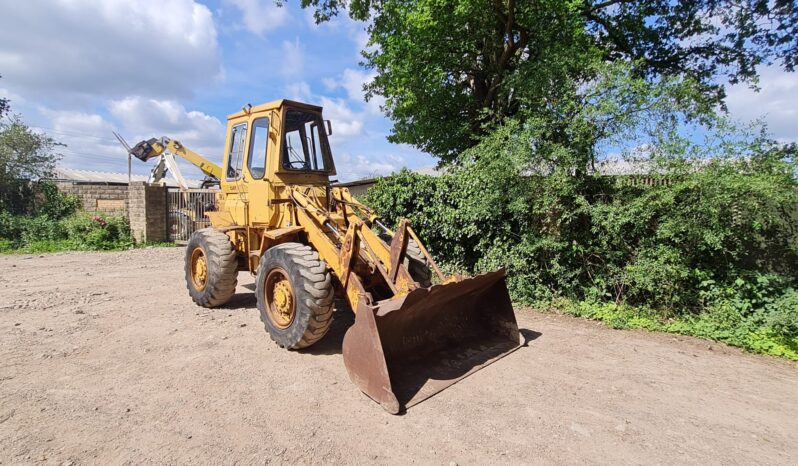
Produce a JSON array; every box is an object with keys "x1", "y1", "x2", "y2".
[{"x1": 726, "y1": 66, "x2": 798, "y2": 141}]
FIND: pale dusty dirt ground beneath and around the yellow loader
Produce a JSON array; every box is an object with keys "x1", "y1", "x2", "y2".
[{"x1": 0, "y1": 248, "x2": 798, "y2": 464}]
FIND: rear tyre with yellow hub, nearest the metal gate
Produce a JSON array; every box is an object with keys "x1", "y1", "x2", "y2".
[{"x1": 185, "y1": 228, "x2": 238, "y2": 308}]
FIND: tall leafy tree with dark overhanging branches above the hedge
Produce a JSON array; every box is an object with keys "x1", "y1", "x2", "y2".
[{"x1": 300, "y1": 0, "x2": 798, "y2": 161}]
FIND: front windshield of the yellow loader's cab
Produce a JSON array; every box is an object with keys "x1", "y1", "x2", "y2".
[{"x1": 283, "y1": 108, "x2": 332, "y2": 172}]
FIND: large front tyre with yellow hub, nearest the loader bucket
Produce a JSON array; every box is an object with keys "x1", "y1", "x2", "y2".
[{"x1": 255, "y1": 243, "x2": 334, "y2": 349}]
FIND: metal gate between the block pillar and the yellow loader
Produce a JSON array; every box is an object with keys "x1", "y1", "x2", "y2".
[{"x1": 166, "y1": 188, "x2": 219, "y2": 243}]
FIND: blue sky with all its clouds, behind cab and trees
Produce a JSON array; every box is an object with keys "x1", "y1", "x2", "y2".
[{"x1": 0, "y1": 0, "x2": 798, "y2": 181}]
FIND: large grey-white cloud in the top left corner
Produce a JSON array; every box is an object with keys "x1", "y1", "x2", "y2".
[{"x1": 0, "y1": 0, "x2": 221, "y2": 98}]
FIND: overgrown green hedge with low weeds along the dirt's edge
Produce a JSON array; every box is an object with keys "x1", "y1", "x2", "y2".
[{"x1": 364, "y1": 121, "x2": 798, "y2": 357}]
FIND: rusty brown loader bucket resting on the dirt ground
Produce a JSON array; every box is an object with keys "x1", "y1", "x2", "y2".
[{"x1": 343, "y1": 270, "x2": 520, "y2": 414}]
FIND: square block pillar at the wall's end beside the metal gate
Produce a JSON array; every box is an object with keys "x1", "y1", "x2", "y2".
[{"x1": 127, "y1": 182, "x2": 168, "y2": 243}]
